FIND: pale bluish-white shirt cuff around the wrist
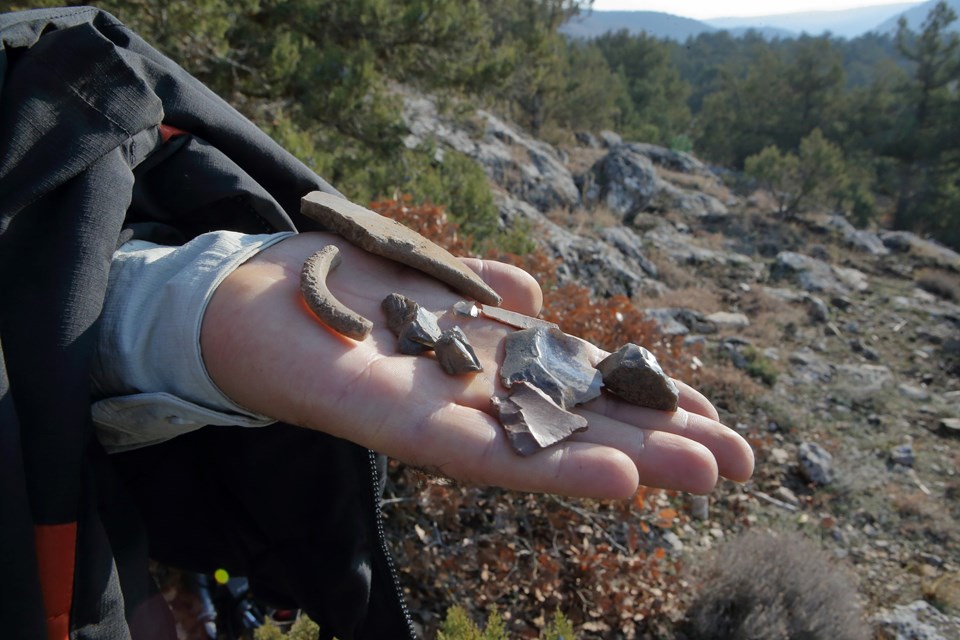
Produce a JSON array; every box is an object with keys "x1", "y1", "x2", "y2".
[{"x1": 92, "y1": 231, "x2": 294, "y2": 451}]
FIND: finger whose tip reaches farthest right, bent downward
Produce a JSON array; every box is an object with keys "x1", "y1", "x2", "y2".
[{"x1": 584, "y1": 396, "x2": 753, "y2": 482}]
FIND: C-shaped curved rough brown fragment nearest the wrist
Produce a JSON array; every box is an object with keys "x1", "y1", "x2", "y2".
[{"x1": 300, "y1": 244, "x2": 373, "y2": 340}]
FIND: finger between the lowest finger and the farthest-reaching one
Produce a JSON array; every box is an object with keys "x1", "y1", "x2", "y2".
[{"x1": 574, "y1": 411, "x2": 718, "y2": 493}]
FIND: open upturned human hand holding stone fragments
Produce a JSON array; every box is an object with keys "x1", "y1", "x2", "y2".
[{"x1": 201, "y1": 233, "x2": 753, "y2": 498}]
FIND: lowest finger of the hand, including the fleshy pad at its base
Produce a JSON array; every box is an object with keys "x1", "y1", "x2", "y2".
[{"x1": 381, "y1": 405, "x2": 638, "y2": 499}]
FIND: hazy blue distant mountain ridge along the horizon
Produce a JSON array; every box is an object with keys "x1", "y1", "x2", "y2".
[{"x1": 561, "y1": 0, "x2": 960, "y2": 42}]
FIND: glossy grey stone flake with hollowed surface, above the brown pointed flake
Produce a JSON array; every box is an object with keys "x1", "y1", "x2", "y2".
[{"x1": 500, "y1": 327, "x2": 603, "y2": 409}]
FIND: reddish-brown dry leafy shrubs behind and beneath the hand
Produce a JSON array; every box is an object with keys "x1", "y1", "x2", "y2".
[{"x1": 374, "y1": 201, "x2": 708, "y2": 638}]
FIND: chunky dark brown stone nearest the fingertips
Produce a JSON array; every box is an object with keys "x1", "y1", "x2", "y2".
[{"x1": 597, "y1": 343, "x2": 680, "y2": 411}]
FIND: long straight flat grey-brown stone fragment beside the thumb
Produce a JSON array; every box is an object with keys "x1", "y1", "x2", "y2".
[{"x1": 300, "y1": 191, "x2": 501, "y2": 305}]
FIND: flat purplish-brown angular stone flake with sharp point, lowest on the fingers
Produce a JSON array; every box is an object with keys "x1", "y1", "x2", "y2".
[{"x1": 492, "y1": 381, "x2": 587, "y2": 456}]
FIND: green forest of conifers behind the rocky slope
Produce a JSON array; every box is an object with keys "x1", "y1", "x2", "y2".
[{"x1": 13, "y1": 0, "x2": 960, "y2": 247}]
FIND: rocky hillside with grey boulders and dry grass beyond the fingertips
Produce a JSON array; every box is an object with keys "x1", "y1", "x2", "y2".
[{"x1": 400, "y1": 89, "x2": 960, "y2": 638}]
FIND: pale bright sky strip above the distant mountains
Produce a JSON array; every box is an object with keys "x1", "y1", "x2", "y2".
[{"x1": 593, "y1": 0, "x2": 920, "y2": 20}]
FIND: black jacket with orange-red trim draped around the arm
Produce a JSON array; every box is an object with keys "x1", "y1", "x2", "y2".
[{"x1": 0, "y1": 7, "x2": 413, "y2": 640}]
